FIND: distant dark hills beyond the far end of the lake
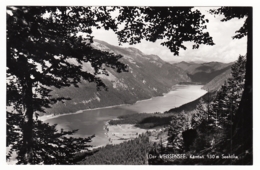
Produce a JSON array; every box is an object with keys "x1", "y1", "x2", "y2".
[{"x1": 173, "y1": 61, "x2": 233, "y2": 84}]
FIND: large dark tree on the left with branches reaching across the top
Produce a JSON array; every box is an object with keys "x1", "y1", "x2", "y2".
[{"x1": 7, "y1": 6, "x2": 214, "y2": 163}]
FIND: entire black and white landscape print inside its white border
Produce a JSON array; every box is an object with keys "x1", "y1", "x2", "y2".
[{"x1": 4, "y1": 5, "x2": 256, "y2": 166}]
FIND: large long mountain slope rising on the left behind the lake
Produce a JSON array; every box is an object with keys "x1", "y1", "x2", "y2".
[{"x1": 46, "y1": 40, "x2": 191, "y2": 114}]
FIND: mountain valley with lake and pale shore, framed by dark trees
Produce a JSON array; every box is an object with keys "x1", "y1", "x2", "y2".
[{"x1": 40, "y1": 40, "x2": 232, "y2": 149}]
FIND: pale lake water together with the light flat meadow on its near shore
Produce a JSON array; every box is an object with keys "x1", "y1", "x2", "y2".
[{"x1": 40, "y1": 85, "x2": 205, "y2": 149}]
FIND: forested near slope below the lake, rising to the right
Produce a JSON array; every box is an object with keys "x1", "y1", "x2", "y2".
[{"x1": 80, "y1": 56, "x2": 248, "y2": 165}]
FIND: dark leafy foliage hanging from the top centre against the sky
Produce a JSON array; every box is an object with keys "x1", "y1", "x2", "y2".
[{"x1": 116, "y1": 7, "x2": 214, "y2": 55}]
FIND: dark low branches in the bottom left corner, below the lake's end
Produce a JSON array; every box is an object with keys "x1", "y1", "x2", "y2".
[{"x1": 8, "y1": 117, "x2": 94, "y2": 164}]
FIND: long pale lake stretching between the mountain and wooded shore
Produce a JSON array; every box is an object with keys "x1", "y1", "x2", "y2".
[{"x1": 46, "y1": 85, "x2": 206, "y2": 146}]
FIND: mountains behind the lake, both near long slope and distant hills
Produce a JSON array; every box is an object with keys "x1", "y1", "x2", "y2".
[{"x1": 42, "y1": 40, "x2": 232, "y2": 115}]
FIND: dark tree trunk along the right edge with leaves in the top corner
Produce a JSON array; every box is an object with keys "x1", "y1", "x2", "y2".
[{"x1": 210, "y1": 7, "x2": 253, "y2": 164}]
